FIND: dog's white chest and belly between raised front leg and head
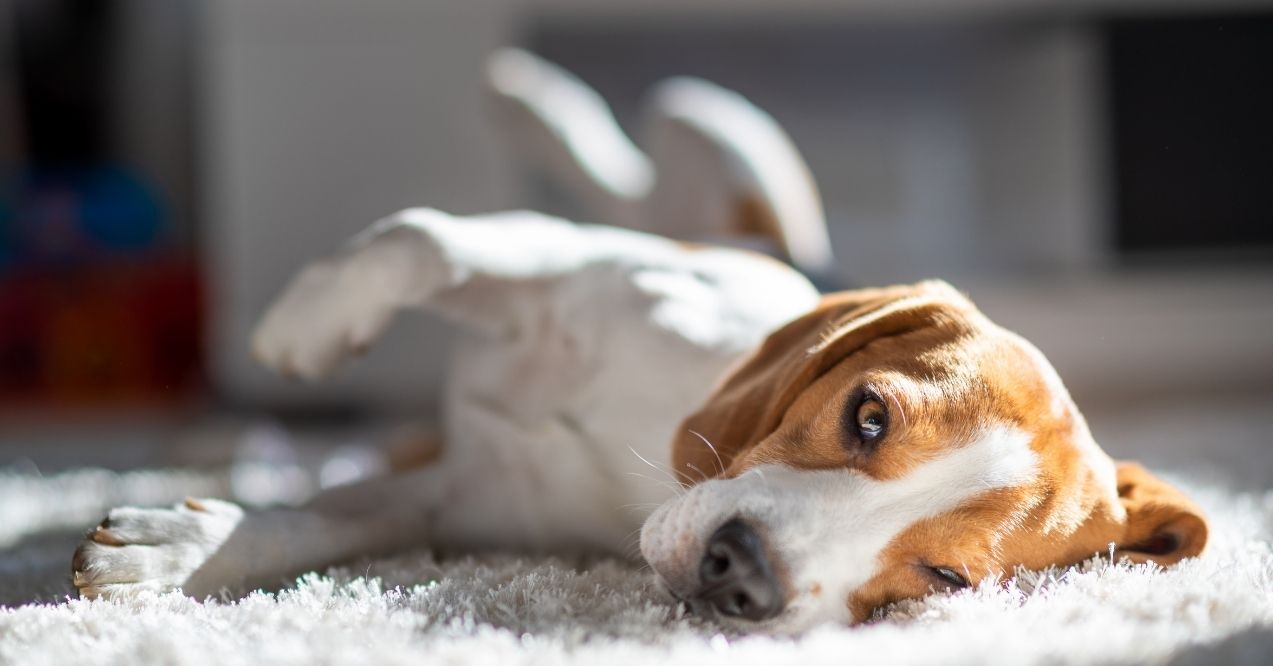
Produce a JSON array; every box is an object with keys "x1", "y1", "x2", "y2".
[{"x1": 440, "y1": 260, "x2": 811, "y2": 554}]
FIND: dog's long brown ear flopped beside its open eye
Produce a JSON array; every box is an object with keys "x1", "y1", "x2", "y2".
[{"x1": 672, "y1": 281, "x2": 973, "y2": 483}]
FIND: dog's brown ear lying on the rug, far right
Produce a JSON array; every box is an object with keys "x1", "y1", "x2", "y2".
[{"x1": 1118, "y1": 462, "x2": 1207, "y2": 565}]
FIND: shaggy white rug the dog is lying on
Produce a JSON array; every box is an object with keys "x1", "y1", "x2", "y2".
[{"x1": 0, "y1": 470, "x2": 1273, "y2": 666}]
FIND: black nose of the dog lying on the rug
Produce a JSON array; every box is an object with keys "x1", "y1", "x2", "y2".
[{"x1": 695, "y1": 518, "x2": 783, "y2": 621}]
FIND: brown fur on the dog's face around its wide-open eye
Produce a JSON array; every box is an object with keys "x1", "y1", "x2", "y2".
[{"x1": 748, "y1": 318, "x2": 1077, "y2": 479}]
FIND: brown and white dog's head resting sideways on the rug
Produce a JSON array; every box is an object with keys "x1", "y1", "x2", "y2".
[{"x1": 642, "y1": 283, "x2": 1207, "y2": 630}]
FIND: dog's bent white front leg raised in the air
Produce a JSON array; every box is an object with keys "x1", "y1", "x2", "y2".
[{"x1": 253, "y1": 209, "x2": 680, "y2": 379}]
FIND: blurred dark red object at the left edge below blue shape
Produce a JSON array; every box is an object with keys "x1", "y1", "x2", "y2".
[{"x1": 0, "y1": 256, "x2": 205, "y2": 410}]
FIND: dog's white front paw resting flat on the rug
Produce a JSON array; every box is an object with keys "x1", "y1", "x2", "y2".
[{"x1": 71, "y1": 499, "x2": 243, "y2": 599}]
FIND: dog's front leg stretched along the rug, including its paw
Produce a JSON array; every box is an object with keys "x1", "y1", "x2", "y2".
[{"x1": 71, "y1": 467, "x2": 449, "y2": 599}]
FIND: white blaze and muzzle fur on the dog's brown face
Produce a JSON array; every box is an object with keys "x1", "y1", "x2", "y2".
[{"x1": 642, "y1": 425, "x2": 1037, "y2": 630}]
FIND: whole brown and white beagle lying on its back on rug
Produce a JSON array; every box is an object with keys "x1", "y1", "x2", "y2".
[{"x1": 73, "y1": 52, "x2": 1207, "y2": 632}]
